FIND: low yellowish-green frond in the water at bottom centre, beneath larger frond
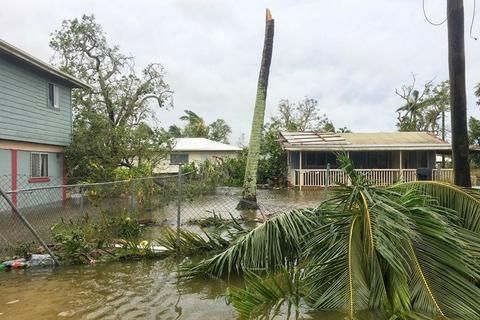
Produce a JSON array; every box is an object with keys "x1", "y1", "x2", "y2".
[{"x1": 228, "y1": 268, "x2": 305, "y2": 319}]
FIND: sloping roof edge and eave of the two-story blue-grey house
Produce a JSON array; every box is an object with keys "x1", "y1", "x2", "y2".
[{"x1": 0, "y1": 39, "x2": 90, "y2": 89}]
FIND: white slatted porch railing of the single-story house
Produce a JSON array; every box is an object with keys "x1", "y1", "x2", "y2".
[{"x1": 291, "y1": 169, "x2": 453, "y2": 187}]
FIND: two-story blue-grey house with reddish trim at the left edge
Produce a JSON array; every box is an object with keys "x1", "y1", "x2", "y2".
[{"x1": 0, "y1": 40, "x2": 88, "y2": 202}]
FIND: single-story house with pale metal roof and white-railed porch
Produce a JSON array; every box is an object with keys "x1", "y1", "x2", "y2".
[{"x1": 280, "y1": 132, "x2": 464, "y2": 188}]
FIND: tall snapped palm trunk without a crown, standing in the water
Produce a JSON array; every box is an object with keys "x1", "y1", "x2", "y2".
[{"x1": 237, "y1": 9, "x2": 274, "y2": 209}]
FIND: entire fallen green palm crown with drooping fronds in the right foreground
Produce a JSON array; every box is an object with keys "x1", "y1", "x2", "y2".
[{"x1": 185, "y1": 155, "x2": 480, "y2": 320}]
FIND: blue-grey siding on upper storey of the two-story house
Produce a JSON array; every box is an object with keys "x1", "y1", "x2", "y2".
[{"x1": 0, "y1": 55, "x2": 72, "y2": 146}]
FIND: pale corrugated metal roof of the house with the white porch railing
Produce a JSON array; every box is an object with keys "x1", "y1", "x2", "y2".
[{"x1": 280, "y1": 132, "x2": 451, "y2": 151}]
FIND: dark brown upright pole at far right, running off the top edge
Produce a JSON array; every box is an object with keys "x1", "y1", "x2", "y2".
[{"x1": 447, "y1": 0, "x2": 471, "y2": 187}]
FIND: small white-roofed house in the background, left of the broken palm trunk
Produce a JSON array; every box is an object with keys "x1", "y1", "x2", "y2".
[{"x1": 156, "y1": 138, "x2": 242, "y2": 173}]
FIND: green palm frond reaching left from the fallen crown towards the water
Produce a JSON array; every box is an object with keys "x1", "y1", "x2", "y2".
[{"x1": 184, "y1": 210, "x2": 319, "y2": 276}]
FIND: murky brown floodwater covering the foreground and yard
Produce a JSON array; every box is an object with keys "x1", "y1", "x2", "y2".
[{"x1": 0, "y1": 190, "x2": 343, "y2": 320}]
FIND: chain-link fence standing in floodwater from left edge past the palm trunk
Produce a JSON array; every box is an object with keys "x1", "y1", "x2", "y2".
[{"x1": 0, "y1": 173, "x2": 318, "y2": 256}]
